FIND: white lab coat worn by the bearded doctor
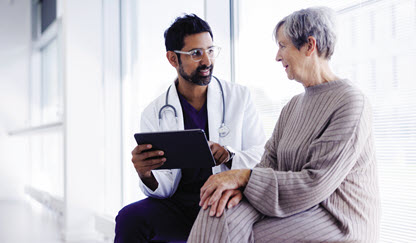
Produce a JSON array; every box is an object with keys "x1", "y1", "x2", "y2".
[{"x1": 140, "y1": 78, "x2": 266, "y2": 198}]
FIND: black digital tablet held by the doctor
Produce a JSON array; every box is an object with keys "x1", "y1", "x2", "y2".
[{"x1": 134, "y1": 129, "x2": 215, "y2": 169}]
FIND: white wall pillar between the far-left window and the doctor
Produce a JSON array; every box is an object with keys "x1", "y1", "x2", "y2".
[{"x1": 63, "y1": 0, "x2": 105, "y2": 241}]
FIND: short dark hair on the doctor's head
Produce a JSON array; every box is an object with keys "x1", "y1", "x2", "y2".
[{"x1": 164, "y1": 14, "x2": 214, "y2": 51}]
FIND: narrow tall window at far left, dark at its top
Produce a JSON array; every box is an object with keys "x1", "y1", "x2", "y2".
[{"x1": 27, "y1": 1, "x2": 64, "y2": 199}]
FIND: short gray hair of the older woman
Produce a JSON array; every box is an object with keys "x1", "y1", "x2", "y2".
[{"x1": 274, "y1": 7, "x2": 337, "y2": 59}]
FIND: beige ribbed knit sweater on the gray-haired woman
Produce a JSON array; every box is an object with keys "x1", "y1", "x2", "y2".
[{"x1": 244, "y1": 80, "x2": 380, "y2": 242}]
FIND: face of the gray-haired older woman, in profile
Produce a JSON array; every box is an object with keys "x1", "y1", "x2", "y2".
[{"x1": 276, "y1": 25, "x2": 306, "y2": 82}]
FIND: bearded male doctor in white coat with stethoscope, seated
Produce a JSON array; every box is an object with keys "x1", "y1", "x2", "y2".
[{"x1": 115, "y1": 14, "x2": 265, "y2": 242}]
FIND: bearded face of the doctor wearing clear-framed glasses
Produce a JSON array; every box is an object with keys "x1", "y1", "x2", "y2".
[{"x1": 178, "y1": 32, "x2": 214, "y2": 85}]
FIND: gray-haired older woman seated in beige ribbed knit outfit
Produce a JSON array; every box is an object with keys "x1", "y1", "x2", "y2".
[{"x1": 188, "y1": 8, "x2": 380, "y2": 242}]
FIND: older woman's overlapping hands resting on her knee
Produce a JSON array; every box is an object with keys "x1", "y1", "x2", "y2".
[{"x1": 199, "y1": 169, "x2": 250, "y2": 216}]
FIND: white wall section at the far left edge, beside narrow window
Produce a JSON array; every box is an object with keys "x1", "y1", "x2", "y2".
[{"x1": 0, "y1": 0, "x2": 31, "y2": 200}]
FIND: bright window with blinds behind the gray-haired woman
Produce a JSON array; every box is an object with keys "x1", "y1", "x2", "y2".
[{"x1": 236, "y1": 0, "x2": 416, "y2": 242}]
